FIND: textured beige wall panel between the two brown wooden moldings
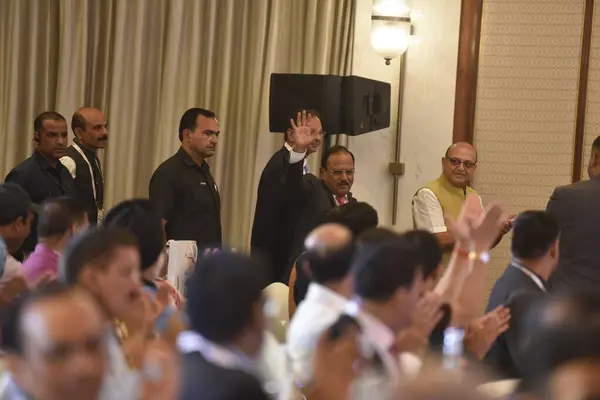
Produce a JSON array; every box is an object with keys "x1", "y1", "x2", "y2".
[{"x1": 474, "y1": 0, "x2": 580, "y2": 287}]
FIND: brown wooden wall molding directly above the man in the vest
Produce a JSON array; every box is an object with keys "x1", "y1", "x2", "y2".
[{"x1": 452, "y1": 0, "x2": 483, "y2": 144}]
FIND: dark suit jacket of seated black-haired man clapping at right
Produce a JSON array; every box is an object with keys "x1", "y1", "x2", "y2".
[{"x1": 485, "y1": 266, "x2": 545, "y2": 379}]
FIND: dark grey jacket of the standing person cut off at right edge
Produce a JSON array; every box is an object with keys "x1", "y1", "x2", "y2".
[{"x1": 546, "y1": 177, "x2": 600, "y2": 291}]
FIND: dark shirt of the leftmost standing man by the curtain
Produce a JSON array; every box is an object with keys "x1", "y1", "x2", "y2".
[{"x1": 5, "y1": 151, "x2": 77, "y2": 258}]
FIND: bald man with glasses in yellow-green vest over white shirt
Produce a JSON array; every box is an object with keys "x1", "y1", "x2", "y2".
[{"x1": 412, "y1": 142, "x2": 512, "y2": 250}]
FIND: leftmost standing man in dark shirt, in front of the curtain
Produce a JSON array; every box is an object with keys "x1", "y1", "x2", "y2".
[{"x1": 5, "y1": 111, "x2": 75, "y2": 260}]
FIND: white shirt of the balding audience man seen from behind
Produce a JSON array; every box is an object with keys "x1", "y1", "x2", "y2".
[{"x1": 287, "y1": 282, "x2": 348, "y2": 384}]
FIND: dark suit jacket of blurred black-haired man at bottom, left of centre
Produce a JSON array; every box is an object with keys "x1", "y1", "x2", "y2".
[{"x1": 179, "y1": 352, "x2": 269, "y2": 400}]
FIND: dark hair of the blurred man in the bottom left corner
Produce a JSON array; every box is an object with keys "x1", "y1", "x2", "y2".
[{"x1": 0, "y1": 281, "x2": 75, "y2": 355}]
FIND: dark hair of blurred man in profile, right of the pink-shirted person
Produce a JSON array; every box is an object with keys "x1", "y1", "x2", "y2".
[{"x1": 58, "y1": 227, "x2": 138, "y2": 285}]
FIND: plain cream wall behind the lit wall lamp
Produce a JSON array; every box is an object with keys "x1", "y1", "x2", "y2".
[{"x1": 349, "y1": 0, "x2": 461, "y2": 230}]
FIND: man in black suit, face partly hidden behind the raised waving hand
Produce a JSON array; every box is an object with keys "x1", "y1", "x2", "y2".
[{"x1": 250, "y1": 110, "x2": 323, "y2": 284}]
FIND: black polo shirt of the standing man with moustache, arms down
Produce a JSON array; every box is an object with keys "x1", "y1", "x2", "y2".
[{"x1": 150, "y1": 148, "x2": 221, "y2": 249}]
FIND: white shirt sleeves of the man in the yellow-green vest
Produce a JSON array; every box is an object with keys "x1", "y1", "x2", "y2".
[{"x1": 412, "y1": 188, "x2": 483, "y2": 233}]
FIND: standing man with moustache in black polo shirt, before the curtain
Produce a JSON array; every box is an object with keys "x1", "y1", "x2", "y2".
[{"x1": 150, "y1": 108, "x2": 221, "y2": 249}]
